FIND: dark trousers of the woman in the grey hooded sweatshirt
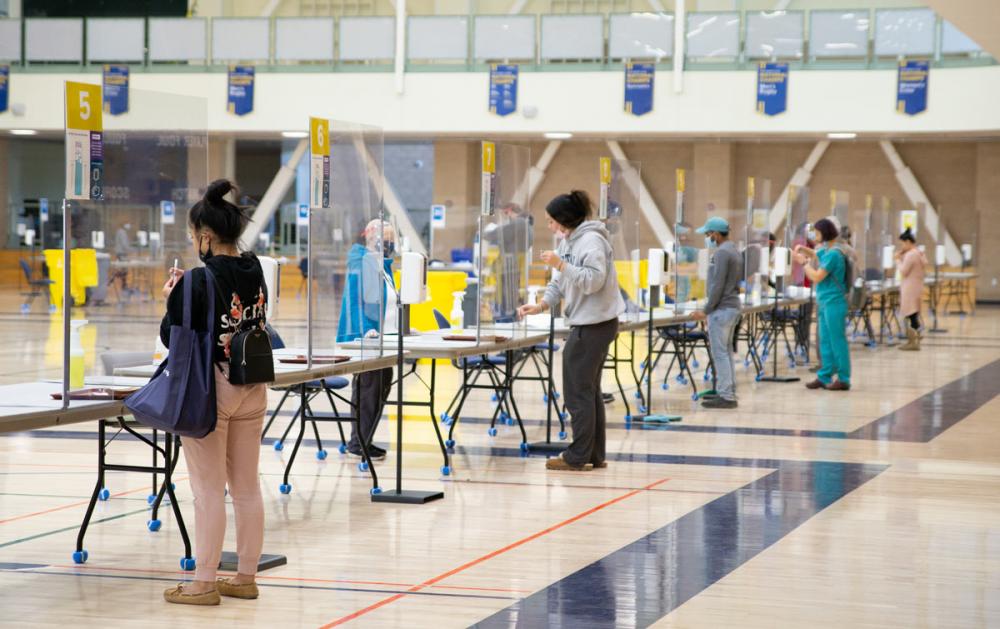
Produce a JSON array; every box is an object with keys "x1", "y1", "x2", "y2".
[{"x1": 563, "y1": 319, "x2": 618, "y2": 465}]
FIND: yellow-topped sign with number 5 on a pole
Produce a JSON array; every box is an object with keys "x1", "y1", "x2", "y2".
[{"x1": 66, "y1": 81, "x2": 104, "y2": 199}]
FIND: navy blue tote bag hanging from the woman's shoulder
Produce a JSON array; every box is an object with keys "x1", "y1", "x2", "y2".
[{"x1": 125, "y1": 269, "x2": 217, "y2": 439}]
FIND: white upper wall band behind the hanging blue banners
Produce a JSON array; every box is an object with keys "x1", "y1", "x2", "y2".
[{"x1": 0, "y1": 66, "x2": 1000, "y2": 137}]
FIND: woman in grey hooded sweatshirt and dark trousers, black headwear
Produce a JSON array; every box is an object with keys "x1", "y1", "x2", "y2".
[{"x1": 518, "y1": 190, "x2": 625, "y2": 470}]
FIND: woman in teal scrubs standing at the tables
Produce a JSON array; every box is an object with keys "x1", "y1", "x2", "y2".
[{"x1": 795, "y1": 218, "x2": 851, "y2": 391}]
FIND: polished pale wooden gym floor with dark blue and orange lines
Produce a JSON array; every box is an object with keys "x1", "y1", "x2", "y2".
[{"x1": 0, "y1": 290, "x2": 1000, "y2": 628}]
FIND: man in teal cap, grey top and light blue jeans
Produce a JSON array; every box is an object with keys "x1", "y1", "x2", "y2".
[{"x1": 693, "y1": 216, "x2": 743, "y2": 409}]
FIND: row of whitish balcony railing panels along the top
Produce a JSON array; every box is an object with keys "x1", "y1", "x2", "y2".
[{"x1": 0, "y1": 8, "x2": 994, "y2": 71}]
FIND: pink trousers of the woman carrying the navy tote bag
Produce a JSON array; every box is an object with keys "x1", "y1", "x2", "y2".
[{"x1": 182, "y1": 369, "x2": 267, "y2": 582}]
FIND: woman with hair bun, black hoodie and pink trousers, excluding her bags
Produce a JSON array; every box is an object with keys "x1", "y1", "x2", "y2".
[{"x1": 160, "y1": 179, "x2": 267, "y2": 605}]
